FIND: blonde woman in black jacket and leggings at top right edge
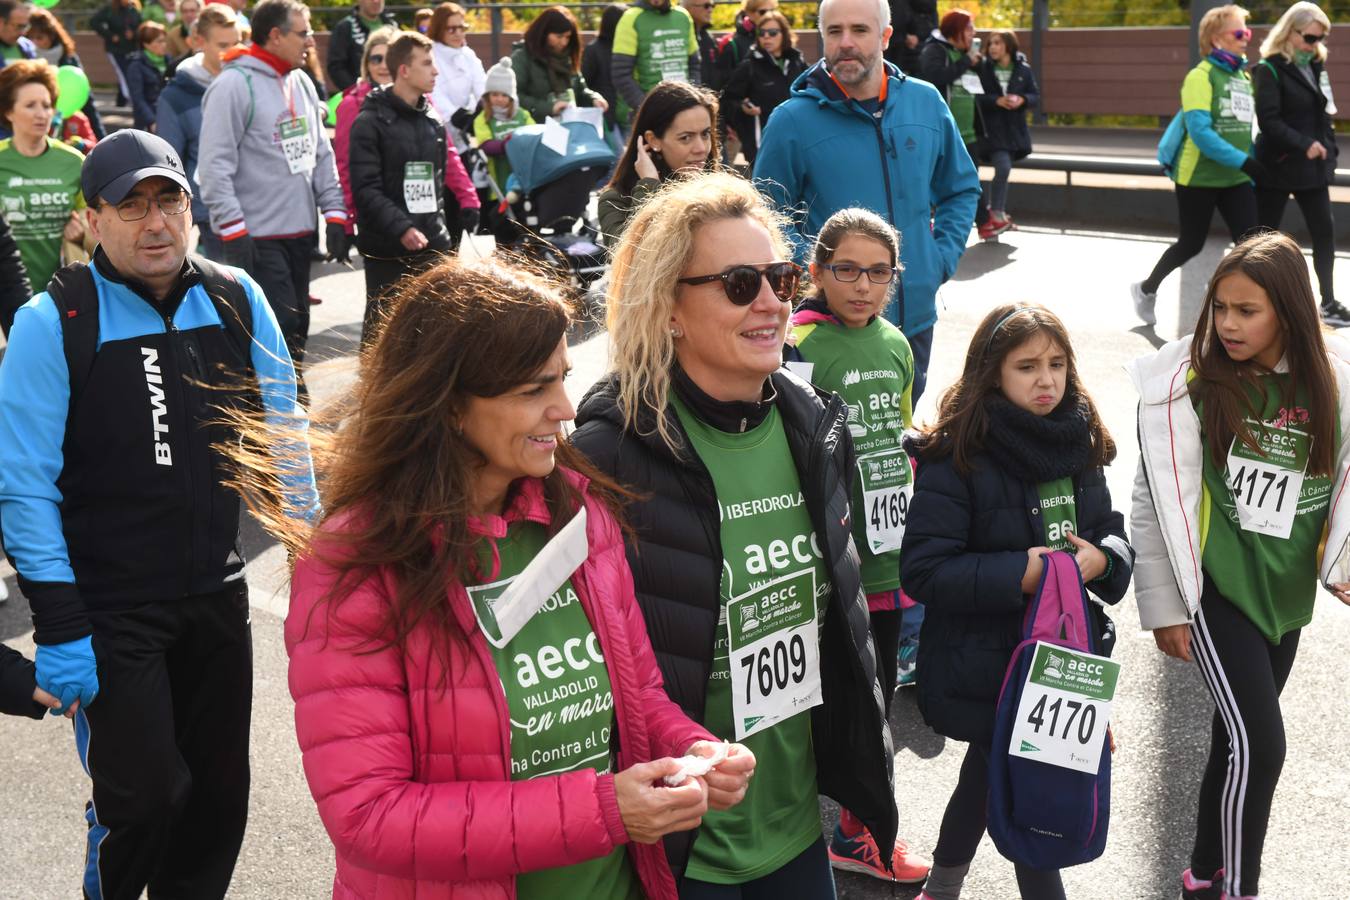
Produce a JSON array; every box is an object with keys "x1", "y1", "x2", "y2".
[{"x1": 1251, "y1": 3, "x2": 1350, "y2": 328}]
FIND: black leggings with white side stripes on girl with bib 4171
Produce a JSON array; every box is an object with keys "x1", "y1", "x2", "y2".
[{"x1": 1191, "y1": 578, "x2": 1299, "y2": 896}]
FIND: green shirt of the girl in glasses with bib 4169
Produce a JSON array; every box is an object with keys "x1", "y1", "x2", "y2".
[{"x1": 792, "y1": 318, "x2": 914, "y2": 594}]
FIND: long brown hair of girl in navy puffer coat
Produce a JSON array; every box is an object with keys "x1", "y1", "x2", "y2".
[{"x1": 918, "y1": 304, "x2": 1115, "y2": 475}]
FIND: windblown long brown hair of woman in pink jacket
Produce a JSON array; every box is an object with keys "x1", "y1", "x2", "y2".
[{"x1": 230, "y1": 256, "x2": 626, "y2": 658}]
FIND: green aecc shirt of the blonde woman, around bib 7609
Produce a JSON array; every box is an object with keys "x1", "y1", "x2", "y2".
[{"x1": 671, "y1": 393, "x2": 830, "y2": 884}]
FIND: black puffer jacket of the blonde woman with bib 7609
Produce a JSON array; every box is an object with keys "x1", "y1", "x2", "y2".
[{"x1": 572, "y1": 370, "x2": 898, "y2": 876}]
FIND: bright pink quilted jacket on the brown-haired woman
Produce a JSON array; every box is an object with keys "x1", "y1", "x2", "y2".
[{"x1": 286, "y1": 472, "x2": 714, "y2": 900}]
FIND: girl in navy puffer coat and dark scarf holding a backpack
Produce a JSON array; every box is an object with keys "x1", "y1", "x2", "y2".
[{"x1": 900, "y1": 305, "x2": 1134, "y2": 900}]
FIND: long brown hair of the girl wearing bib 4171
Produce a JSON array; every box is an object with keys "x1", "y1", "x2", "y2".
[{"x1": 1191, "y1": 231, "x2": 1337, "y2": 475}]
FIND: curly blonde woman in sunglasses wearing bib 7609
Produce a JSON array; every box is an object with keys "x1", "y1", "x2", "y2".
[{"x1": 574, "y1": 174, "x2": 896, "y2": 900}]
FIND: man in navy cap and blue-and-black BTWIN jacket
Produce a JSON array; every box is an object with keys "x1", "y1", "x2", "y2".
[{"x1": 0, "y1": 130, "x2": 316, "y2": 900}]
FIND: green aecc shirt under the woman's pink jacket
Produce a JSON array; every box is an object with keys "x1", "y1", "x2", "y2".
[{"x1": 467, "y1": 522, "x2": 643, "y2": 900}]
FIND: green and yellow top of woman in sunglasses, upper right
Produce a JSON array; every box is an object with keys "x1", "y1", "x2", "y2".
[{"x1": 1177, "y1": 59, "x2": 1256, "y2": 188}]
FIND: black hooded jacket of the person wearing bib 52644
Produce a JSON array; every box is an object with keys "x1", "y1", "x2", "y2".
[{"x1": 347, "y1": 86, "x2": 450, "y2": 258}]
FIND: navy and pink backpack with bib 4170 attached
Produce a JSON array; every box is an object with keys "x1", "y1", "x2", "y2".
[{"x1": 988, "y1": 552, "x2": 1111, "y2": 869}]
